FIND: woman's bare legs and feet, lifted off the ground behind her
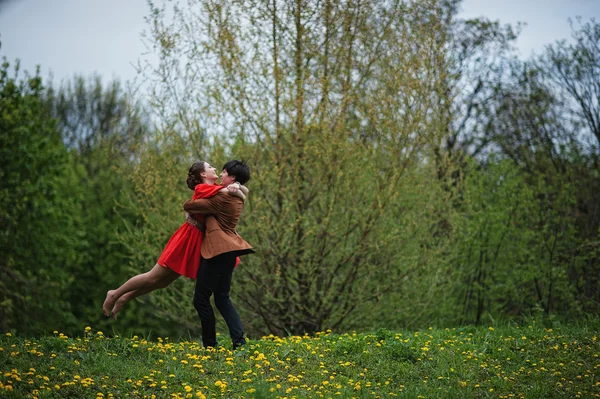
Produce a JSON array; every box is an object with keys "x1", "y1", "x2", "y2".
[{"x1": 102, "y1": 263, "x2": 179, "y2": 316}]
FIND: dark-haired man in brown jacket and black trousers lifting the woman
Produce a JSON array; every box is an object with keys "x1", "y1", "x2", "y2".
[{"x1": 183, "y1": 160, "x2": 254, "y2": 349}]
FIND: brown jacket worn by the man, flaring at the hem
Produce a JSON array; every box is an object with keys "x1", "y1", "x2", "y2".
[{"x1": 183, "y1": 193, "x2": 254, "y2": 259}]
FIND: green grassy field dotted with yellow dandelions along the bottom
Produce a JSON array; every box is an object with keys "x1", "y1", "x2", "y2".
[{"x1": 0, "y1": 320, "x2": 600, "y2": 399}]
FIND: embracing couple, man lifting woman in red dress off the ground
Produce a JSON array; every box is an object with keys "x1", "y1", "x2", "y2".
[{"x1": 102, "y1": 160, "x2": 254, "y2": 349}]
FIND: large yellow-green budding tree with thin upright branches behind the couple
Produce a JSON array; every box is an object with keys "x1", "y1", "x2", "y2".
[{"x1": 127, "y1": 0, "x2": 448, "y2": 334}]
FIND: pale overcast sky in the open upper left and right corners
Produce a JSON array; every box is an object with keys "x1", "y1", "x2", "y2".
[{"x1": 0, "y1": 0, "x2": 600, "y2": 80}]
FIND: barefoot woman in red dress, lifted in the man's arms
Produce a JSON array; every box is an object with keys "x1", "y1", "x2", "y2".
[{"x1": 102, "y1": 161, "x2": 248, "y2": 319}]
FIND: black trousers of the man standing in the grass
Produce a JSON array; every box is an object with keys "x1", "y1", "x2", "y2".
[{"x1": 194, "y1": 252, "x2": 246, "y2": 349}]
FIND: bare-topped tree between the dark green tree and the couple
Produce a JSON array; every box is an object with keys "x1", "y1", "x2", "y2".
[{"x1": 44, "y1": 76, "x2": 164, "y2": 333}]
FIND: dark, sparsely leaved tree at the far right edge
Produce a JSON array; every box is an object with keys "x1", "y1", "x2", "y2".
[{"x1": 476, "y1": 24, "x2": 600, "y2": 318}]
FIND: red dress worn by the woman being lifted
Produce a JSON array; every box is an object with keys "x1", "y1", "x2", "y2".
[{"x1": 157, "y1": 184, "x2": 239, "y2": 279}]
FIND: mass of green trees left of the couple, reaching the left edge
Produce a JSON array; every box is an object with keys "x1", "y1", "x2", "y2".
[{"x1": 0, "y1": 64, "x2": 173, "y2": 334}]
